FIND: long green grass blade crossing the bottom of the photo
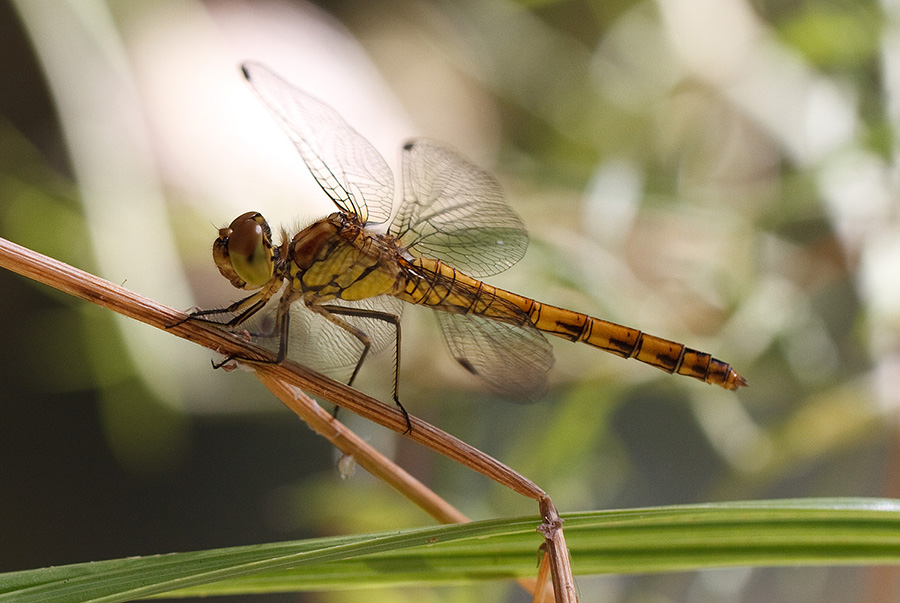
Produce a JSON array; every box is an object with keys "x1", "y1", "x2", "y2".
[{"x1": 0, "y1": 499, "x2": 900, "y2": 603}]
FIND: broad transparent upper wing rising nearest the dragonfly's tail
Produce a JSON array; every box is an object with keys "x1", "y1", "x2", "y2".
[{"x1": 390, "y1": 139, "x2": 528, "y2": 277}]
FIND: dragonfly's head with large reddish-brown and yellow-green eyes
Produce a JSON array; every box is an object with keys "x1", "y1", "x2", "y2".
[{"x1": 213, "y1": 211, "x2": 274, "y2": 289}]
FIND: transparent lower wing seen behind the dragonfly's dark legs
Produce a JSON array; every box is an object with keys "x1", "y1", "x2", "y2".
[{"x1": 247, "y1": 296, "x2": 403, "y2": 383}]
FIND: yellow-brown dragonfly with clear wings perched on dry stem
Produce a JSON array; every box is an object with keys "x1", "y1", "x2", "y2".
[{"x1": 190, "y1": 63, "x2": 747, "y2": 426}]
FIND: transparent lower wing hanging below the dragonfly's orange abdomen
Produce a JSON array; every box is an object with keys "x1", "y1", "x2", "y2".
[{"x1": 436, "y1": 312, "x2": 553, "y2": 402}]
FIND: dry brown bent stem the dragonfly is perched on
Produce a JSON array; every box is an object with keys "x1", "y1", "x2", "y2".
[{"x1": 0, "y1": 238, "x2": 576, "y2": 602}]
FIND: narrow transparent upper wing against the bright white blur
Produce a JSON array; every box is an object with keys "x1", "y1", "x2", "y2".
[{"x1": 241, "y1": 63, "x2": 394, "y2": 223}]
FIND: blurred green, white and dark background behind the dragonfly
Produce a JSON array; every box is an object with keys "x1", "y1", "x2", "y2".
[{"x1": 0, "y1": 0, "x2": 900, "y2": 602}]
